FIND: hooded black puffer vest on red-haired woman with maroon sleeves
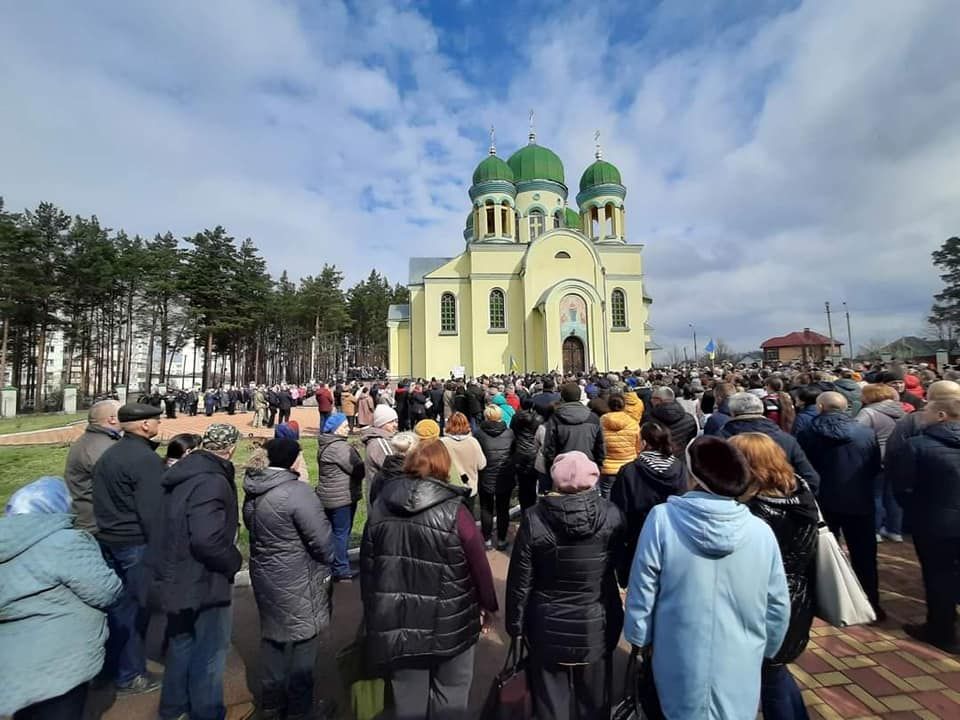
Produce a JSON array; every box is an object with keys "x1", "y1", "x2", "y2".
[{"x1": 360, "y1": 476, "x2": 480, "y2": 670}]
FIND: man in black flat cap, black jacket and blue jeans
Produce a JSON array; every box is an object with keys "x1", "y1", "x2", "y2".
[{"x1": 93, "y1": 403, "x2": 164, "y2": 695}]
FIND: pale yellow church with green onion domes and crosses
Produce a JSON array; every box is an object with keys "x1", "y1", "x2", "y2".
[{"x1": 387, "y1": 128, "x2": 657, "y2": 378}]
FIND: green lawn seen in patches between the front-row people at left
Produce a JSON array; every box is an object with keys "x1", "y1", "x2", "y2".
[{"x1": 0, "y1": 434, "x2": 367, "y2": 557}]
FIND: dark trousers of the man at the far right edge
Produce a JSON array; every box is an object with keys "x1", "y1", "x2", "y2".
[{"x1": 913, "y1": 532, "x2": 960, "y2": 643}]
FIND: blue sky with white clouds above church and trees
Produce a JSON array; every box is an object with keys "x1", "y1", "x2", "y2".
[{"x1": 0, "y1": 0, "x2": 960, "y2": 360}]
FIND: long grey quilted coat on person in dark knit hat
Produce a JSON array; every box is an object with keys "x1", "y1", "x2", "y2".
[{"x1": 243, "y1": 467, "x2": 334, "y2": 642}]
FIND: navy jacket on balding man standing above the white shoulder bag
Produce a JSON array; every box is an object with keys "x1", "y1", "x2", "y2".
[{"x1": 797, "y1": 412, "x2": 881, "y2": 515}]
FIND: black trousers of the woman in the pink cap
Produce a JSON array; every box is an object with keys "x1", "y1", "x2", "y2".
[{"x1": 527, "y1": 658, "x2": 610, "y2": 720}]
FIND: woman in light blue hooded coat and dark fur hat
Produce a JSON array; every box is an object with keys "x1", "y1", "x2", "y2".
[{"x1": 623, "y1": 437, "x2": 790, "y2": 720}]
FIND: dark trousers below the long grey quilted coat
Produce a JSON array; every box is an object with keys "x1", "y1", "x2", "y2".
[{"x1": 260, "y1": 635, "x2": 320, "y2": 717}]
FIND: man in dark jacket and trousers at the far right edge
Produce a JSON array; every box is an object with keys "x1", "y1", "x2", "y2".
[{"x1": 886, "y1": 397, "x2": 960, "y2": 654}]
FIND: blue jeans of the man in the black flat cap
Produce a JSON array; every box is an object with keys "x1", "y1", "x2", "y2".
[{"x1": 100, "y1": 542, "x2": 150, "y2": 685}]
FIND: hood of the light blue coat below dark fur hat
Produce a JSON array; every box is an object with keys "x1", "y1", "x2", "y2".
[{"x1": 667, "y1": 490, "x2": 752, "y2": 557}]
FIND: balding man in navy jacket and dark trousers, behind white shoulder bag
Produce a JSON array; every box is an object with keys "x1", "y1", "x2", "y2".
[{"x1": 797, "y1": 392, "x2": 886, "y2": 622}]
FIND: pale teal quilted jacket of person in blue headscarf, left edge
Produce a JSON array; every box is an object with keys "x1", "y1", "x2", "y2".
[{"x1": 0, "y1": 513, "x2": 121, "y2": 715}]
